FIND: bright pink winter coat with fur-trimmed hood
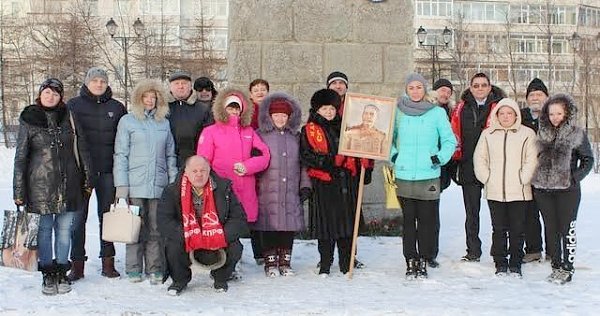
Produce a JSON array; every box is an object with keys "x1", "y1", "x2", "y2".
[{"x1": 197, "y1": 90, "x2": 271, "y2": 223}]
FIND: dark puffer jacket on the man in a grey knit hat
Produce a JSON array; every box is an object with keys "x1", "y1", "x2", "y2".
[{"x1": 67, "y1": 85, "x2": 127, "y2": 174}]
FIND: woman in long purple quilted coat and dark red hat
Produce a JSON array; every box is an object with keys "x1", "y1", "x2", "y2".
[{"x1": 252, "y1": 92, "x2": 310, "y2": 277}]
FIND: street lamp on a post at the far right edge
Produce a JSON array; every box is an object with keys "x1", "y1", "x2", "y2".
[{"x1": 571, "y1": 32, "x2": 600, "y2": 133}]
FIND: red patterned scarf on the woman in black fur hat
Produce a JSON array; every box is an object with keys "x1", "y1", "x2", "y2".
[{"x1": 306, "y1": 122, "x2": 373, "y2": 182}]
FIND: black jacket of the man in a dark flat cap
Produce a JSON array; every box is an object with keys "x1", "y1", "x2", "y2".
[{"x1": 168, "y1": 92, "x2": 213, "y2": 168}]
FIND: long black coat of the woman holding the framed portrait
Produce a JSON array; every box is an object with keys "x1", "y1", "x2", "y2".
[{"x1": 300, "y1": 109, "x2": 364, "y2": 239}]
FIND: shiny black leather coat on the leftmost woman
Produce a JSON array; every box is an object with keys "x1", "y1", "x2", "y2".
[{"x1": 13, "y1": 103, "x2": 90, "y2": 215}]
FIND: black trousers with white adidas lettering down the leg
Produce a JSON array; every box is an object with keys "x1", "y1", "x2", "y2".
[{"x1": 533, "y1": 188, "x2": 581, "y2": 270}]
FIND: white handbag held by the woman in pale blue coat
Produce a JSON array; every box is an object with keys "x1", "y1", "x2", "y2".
[{"x1": 102, "y1": 199, "x2": 142, "y2": 244}]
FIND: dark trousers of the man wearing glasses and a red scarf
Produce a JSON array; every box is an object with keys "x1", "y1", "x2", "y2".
[{"x1": 462, "y1": 184, "x2": 481, "y2": 257}]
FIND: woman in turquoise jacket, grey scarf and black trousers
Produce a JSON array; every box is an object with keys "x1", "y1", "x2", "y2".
[{"x1": 391, "y1": 73, "x2": 456, "y2": 279}]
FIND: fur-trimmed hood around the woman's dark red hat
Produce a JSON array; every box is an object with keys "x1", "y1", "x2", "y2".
[{"x1": 258, "y1": 92, "x2": 302, "y2": 134}]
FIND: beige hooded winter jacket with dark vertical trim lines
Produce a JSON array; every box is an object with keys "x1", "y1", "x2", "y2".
[{"x1": 473, "y1": 98, "x2": 537, "y2": 202}]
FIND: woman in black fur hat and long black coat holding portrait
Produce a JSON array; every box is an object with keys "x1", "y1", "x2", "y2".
[{"x1": 300, "y1": 89, "x2": 372, "y2": 276}]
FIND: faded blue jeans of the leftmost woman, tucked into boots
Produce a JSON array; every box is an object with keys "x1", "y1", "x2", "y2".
[{"x1": 38, "y1": 211, "x2": 75, "y2": 267}]
